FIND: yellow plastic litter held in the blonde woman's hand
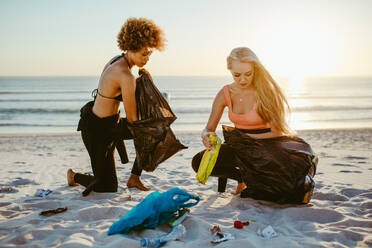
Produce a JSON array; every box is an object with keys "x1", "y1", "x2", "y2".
[{"x1": 196, "y1": 134, "x2": 221, "y2": 184}]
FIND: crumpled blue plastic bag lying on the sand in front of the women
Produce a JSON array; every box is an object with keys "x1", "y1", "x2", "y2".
[{"x1": 108, "y1": 188, "x2": 200, "y2": 235}]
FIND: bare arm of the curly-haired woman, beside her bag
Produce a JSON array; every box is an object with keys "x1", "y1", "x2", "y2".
[{"x1": 120, "y1": 74, "x2": 137, "y2": 122}]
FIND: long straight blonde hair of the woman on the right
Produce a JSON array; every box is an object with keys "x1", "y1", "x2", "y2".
[{"x1": 227, "y1": 47, "x2": 293, "y2": 134}]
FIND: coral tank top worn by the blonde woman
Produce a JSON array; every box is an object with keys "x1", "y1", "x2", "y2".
[{"x1": 223, "y1": 85, "x2": 270, "y2": 129}]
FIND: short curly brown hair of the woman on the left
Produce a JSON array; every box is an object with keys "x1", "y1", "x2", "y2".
[{"x1": 117, "y1": 17, "x2": 166, "y2": 51}]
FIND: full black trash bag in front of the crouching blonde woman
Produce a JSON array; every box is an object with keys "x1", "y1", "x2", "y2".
[{"x1": 223, "y1": 126, "x2": 318, "y2": 204}]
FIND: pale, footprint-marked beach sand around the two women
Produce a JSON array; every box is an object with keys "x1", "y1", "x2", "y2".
[{"x1": 0, "y1": 129, "x2": 372, "y2": 248}]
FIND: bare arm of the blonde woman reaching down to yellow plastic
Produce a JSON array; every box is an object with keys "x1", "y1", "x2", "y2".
[{"x1": 202, "y1": 89, "x2": 226, "y2": 149}]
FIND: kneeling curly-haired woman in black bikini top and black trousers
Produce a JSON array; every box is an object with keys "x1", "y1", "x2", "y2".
[{"x1": 67, "y1": 18, "x2": 165, "y2": 195}]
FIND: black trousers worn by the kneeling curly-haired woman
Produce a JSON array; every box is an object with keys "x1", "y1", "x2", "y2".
[{"x1": 74, "y1": 105, "x2": 142, "y2": 192}]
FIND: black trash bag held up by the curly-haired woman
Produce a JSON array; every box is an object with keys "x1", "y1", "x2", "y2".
[{"x1": 128, "y1": 69, "x2": 187, "y2": 172}]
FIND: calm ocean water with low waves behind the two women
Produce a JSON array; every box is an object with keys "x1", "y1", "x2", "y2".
[{"x1": 0, "y1": 76, "x2": 372, "y2": 134}]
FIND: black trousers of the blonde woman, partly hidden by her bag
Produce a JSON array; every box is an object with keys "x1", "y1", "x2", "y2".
[{"x1": 192, "y1": 144, "x2": 243, "y2": 192}]
